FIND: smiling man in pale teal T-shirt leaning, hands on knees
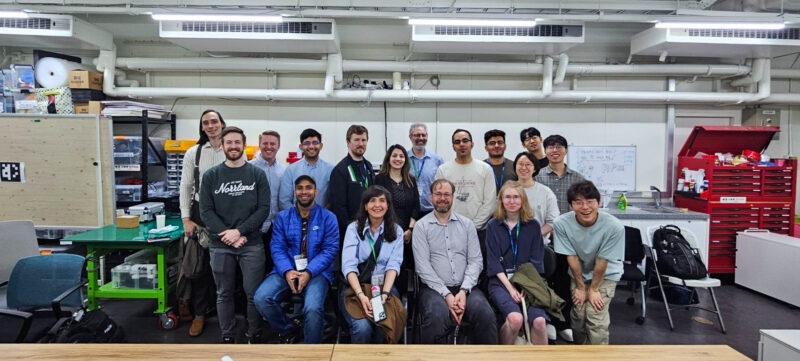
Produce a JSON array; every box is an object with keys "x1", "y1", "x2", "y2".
[{"x1": 553, "y1": 181, "x2": 625, "y2": 345}]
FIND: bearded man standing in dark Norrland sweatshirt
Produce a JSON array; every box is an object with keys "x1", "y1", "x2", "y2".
[{"x1": 200, "y1": 127, "x2": 270, "y2": 343}]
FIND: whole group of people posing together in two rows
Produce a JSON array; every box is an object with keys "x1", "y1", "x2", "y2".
[{"x1": 179, "y1": 110, "x2": 624, "y2": 344}]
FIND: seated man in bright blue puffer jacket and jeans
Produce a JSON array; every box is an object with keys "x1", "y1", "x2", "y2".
[{"x1": 255, "y1": 175, "x2": 339, "y2": 343}]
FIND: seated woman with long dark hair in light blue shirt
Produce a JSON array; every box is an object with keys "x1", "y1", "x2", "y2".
[{"x1": 339, "y1": 185, "x2": 405, "y2": 343}]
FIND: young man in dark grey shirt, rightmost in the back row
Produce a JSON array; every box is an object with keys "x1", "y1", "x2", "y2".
[{"x1": 536, "y1": 135, "x2": 586, "y2": 214}]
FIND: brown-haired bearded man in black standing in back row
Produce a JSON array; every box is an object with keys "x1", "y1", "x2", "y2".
[{"x1": 330, "y1": 125, "x2": 375, "y2": 236}]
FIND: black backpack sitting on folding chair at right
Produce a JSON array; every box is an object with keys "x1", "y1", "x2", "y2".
[{"x1": 653, "y1": 225, "x2": 708, "y2": 279}]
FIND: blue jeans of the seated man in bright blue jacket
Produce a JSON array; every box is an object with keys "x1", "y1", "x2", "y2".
[{"x1": 255, "y1": 273, "x2": 329, "y2": 343}]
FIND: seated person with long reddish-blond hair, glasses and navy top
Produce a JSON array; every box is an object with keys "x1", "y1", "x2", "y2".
[{"x1": 486, "y1": 181, "x2": 550, "y2": 345}]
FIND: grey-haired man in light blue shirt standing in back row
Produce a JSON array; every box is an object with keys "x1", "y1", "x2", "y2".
[{"x1": 408, "y1": 123, "x2": 444, "y2": 218}]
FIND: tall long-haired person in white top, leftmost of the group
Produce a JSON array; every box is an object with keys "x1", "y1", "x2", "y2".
[{"x1": 178, "y1": 109, "x2": 225, "y2": 336}]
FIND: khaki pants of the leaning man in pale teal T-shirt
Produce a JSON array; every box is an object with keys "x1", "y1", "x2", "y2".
[{"x1": 570, "y1": 280, "x2": 617, "y2": 345}]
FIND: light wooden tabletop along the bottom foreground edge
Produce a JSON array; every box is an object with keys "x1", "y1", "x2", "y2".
[{"x1": 0, "y1": 344, "x2": 749, "y2": 361}]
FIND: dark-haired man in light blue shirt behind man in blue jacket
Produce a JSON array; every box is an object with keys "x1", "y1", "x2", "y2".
[{"x1": 278, "y1": 128, "x2": 333, "y2": 211}]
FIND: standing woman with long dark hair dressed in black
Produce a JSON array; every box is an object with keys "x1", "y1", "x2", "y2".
[{"x1": 375, "y1": 144, "x2": 419, "y2": 294}]
